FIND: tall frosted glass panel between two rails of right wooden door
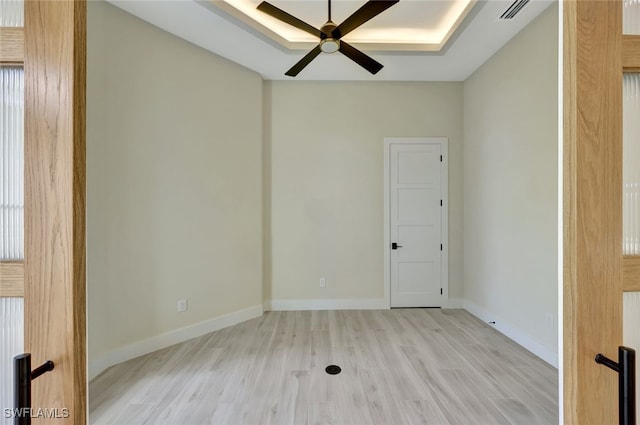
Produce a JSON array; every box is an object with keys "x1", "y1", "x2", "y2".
[{"x1": 622, "y1": 74, "x2": 640, "y2": 255}]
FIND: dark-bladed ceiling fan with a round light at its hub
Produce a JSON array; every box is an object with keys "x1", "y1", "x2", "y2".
[{"x1": 258, "y1": 0, "x2": 400, "y2": 77}]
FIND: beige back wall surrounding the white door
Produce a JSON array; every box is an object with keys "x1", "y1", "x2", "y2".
[{"x1": 264, "y1": 81, "x2": 463, "y2": 301}]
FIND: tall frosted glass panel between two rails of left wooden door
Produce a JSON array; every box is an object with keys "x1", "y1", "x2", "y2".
[{"x1": 0, "y1": 68, "x2": 24, "y2": 260}]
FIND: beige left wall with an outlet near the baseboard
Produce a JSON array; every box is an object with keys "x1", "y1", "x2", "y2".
[{"x1": 87, "y1": 2, "x2": 262, "y2": 361}]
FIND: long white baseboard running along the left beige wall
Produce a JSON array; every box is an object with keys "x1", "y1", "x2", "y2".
[{"x1": 88, "y1": 305, "x2": 263, "y2": 380}]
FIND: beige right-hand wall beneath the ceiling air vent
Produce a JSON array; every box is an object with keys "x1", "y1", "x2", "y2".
[{"x1": 464, "y1": 4, "x2": 558, "y2": 353}]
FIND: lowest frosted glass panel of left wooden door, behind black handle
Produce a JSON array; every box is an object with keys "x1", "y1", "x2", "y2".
[{"x1": 0, "y1": 298, "x2": 24, "y2": 425}]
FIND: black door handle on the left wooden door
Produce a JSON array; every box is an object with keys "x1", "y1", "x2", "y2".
[{"x1": 13, "y1": 353, "x2": 54, "y2": 425}]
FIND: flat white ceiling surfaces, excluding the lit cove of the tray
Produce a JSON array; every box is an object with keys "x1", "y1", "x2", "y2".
[{"x1": 108, "y1": 0, "x2": 552, "y2": 81}]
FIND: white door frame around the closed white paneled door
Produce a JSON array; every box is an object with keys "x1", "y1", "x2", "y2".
[{"x1": 383, "y1": 137, "x2": 451, "y2": 308}]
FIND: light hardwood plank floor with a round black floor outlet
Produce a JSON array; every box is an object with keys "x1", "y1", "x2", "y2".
[{"x1": 89, "y1": 309, "x2": 558, "y2": 425}]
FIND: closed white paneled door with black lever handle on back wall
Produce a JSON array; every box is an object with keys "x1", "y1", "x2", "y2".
[{"x1": 389, "y1": 143, "x2": 443, "y2": 307}]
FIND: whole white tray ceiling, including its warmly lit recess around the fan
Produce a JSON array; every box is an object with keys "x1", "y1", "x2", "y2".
[{"x1": 108, "y1": 0, "x2": 553, "y2": 81}]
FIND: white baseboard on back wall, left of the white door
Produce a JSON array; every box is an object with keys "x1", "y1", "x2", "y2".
[{"x1": 264, "y1": 298, "x2": 389, "y2": 311}]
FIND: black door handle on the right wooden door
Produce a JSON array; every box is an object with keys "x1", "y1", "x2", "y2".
[{"x1": 595, "y1": 347, "x2": 636, "y2": 425}]
